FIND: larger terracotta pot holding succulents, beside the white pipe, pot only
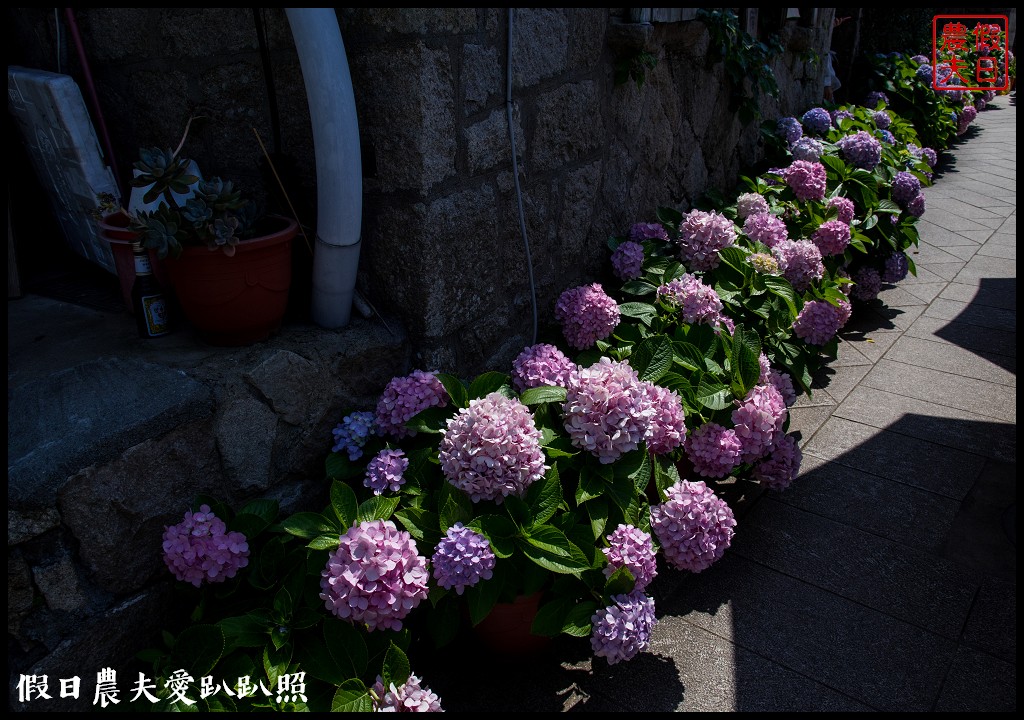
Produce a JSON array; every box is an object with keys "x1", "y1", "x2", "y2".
[{"x1": 166, "y1": 215, "x2": 298, "y2": 345}]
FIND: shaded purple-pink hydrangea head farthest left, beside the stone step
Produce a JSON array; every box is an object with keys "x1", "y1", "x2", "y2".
[{"x1": 163, "y1": 505, "x2": 249, "y2": 588}]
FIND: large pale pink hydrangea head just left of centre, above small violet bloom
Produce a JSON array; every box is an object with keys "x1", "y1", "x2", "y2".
[{"x1": 439, "y1": 392, "x2": 548, "y2": 504}]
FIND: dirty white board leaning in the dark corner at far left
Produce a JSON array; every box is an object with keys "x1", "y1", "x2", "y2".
[{"x1": 7, "y1": 66, "x2": 121, "y2": 273}]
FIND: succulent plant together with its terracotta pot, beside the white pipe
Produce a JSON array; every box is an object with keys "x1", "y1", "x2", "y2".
[{"x1": 130, "y1": 145, "x2": 298, "y2": 345}]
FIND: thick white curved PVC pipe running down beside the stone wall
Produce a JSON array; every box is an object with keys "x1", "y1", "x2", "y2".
[{"x1": 285, "y1": 7, "x2": 362, "y2": 328}]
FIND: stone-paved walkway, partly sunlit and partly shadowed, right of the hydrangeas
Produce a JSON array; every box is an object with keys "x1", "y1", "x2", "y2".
[{"x1": 436, "y1": 96, "x2": 1017, "y2": 712}]
